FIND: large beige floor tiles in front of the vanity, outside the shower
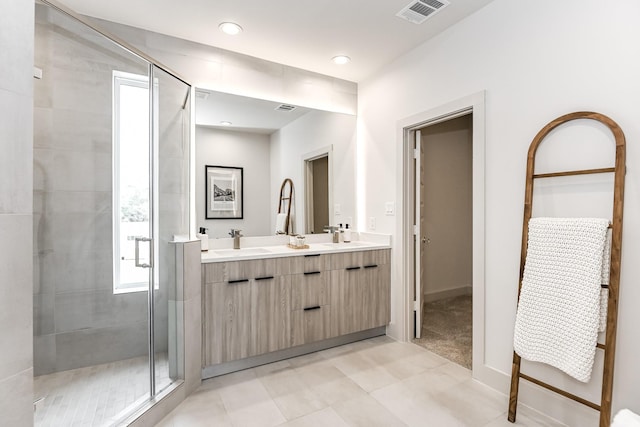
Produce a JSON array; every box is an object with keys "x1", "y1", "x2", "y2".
[{"x1": 159, "y1": 337, "x2": 563, "y2": 427}]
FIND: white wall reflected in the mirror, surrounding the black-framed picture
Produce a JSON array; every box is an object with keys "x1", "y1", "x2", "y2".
[{"x1": 196, "y1": 126, "x2": 275, "y2": 238}]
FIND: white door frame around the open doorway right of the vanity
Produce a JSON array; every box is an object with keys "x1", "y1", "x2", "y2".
[{"x1": 397, "y1": 91, "x2": 485, "y2": 377}]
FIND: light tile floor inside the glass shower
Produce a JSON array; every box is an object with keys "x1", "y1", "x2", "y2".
[{"x1": 33, "y1": 353, "x2": 169, "y2": 427}]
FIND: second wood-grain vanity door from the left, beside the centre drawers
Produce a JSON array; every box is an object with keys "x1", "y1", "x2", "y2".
[{"x1": 251, "y1": 276, "x2": 291, "y2": 356}]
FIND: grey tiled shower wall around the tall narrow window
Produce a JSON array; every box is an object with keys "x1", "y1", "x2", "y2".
[{"x1": 33, "y1": 6, "x2": 167, "y2": 375}]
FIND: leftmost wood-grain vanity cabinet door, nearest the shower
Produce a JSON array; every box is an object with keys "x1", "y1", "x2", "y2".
[{"x1": 202, "y1": 280, "x2": 251, "y2": 366}]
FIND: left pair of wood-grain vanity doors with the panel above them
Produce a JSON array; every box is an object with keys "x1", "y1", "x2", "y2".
[{"x1": 202, "y1": 258, "x2": 291, "y2": 366}]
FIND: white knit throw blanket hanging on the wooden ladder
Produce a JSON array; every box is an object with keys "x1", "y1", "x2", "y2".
[{"x1": 514, "y1": 218, "x2": 609, "y2": 382}]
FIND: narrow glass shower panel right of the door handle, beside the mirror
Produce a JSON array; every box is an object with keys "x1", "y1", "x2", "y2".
[{"x1": 152, "y1": 66, "x2": 191, "y2": 393}]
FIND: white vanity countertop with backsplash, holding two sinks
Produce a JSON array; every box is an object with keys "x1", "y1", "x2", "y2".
[{"x1": 202, "y1": 233, "x2": 391, "y2": 263}]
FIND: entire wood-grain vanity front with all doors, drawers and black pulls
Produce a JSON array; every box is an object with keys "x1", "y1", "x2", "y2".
[{"x1": 202, "y1": 249, "x2": 391, "y2": 367}]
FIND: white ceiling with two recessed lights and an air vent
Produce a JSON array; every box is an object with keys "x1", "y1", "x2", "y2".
[{"x1": 60, "y1": 0, "x2": 492, "y2": 82}]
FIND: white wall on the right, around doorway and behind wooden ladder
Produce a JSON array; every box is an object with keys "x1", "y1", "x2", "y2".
[{"x1": 358, "y1": 0, "x2": 640, "y2": 425}]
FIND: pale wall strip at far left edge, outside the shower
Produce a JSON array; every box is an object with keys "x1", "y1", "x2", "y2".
[{"x1": 0, "y1": 0, "x2": 34, "y2": 426}]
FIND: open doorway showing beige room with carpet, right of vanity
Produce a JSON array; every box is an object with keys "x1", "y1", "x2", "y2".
[{"x1": 414, "y1": 113, "x2": 473, "y2": 369}]
